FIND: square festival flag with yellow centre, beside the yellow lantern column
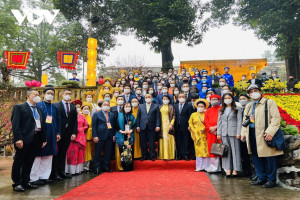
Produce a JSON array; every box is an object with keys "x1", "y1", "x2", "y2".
[{"x1": 57, "y1": 51, "x2": 79, "y2": 70}]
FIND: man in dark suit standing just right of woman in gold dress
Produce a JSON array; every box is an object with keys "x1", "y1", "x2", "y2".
[{"x1": 174, "y1": 93, "x2": 191, "y2": 160}]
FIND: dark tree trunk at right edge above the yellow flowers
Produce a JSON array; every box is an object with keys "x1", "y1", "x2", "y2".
[{"x1": 285, "y1": 37, "x2": 300, "y2": 80}]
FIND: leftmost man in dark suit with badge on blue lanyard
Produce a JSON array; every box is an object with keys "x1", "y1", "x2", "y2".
[{"x1": 11, "y1": 89, "x2": 47, "y2": 192}]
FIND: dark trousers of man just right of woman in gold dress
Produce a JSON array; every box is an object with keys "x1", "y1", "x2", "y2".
[{"x1": 175, "y1": 129, "x2": 191, "y2": 157}]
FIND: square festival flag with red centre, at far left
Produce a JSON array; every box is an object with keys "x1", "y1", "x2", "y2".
[{"x1": 3, "y1": 51, "x2": 30, "y2": 70}]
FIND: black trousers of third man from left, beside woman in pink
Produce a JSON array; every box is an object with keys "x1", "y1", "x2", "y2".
[{"x1": 52, "y1": 136, "x2": 71, "y2": 174}]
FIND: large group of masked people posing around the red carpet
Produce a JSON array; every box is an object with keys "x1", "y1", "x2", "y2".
[{"x1": 12, "y1": 67, "x2": 283, "y2": 191}]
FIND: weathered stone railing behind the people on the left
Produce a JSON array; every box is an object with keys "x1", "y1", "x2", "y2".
[{"x1": 0, "y1": 86, "x2": 100, "y2": 102}]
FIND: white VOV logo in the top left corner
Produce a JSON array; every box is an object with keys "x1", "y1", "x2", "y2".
[{"x1": 11, "y1": 9, "x2": 59, "y2": 25}]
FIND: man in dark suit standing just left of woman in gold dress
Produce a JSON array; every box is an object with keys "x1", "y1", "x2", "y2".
[{"x1": 136, "y1": 94, "x2": 161, "y2": 161}]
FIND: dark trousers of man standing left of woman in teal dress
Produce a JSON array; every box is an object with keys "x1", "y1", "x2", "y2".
[{"x1": 94, "y1": 133, "x2": 113, "y2": 170}]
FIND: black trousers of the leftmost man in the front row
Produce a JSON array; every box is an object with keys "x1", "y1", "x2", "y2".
[{"x1": 11, "y1": 143, "x2": 41, "y2": 187}]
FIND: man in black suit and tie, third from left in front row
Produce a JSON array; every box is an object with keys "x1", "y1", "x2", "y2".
[{"x1": 52, "y1": 89, "x2": 78, "y2": 180}]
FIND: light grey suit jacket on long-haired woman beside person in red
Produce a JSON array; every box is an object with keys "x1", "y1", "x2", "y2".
[{"x1": 217, "y1": 107, "x2": 242, "y2": 136}]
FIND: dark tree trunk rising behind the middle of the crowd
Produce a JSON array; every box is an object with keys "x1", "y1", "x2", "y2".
[{"x1": 161, "y1": 41, "x2": 174, "y2": 72}]
